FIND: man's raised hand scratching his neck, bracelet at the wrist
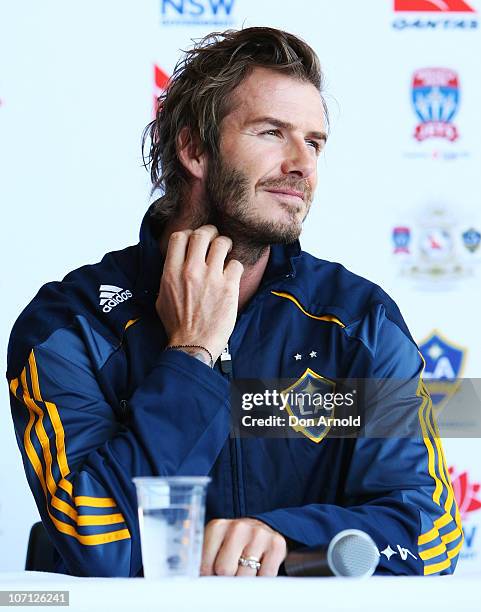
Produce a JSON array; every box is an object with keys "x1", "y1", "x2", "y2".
[{"x1": 155, "y1": 225, "x2": 244, "y2": 361}]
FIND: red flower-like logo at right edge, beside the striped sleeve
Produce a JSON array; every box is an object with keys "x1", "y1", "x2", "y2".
[{"x1": 449, "y1": 467, "x2": 481, "y2": 561}]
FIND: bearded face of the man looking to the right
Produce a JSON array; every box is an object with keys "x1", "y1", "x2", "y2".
[{"x1": 202, "y1": 68, "x2": 326, "y2": 247}]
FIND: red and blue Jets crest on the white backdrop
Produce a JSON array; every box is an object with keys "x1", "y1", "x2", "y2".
[{"x1": 411, "y1": 68, "x2": 460, "y2": 142}]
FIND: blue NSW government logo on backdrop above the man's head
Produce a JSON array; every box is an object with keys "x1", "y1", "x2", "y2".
[{"x1": 160, "y1": 0, "x2": 236, "y2": 26}]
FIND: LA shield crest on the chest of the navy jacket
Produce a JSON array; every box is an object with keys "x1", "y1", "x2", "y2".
[{"x1": 281, "y1": 368, "x2": 336, "y2": 442}]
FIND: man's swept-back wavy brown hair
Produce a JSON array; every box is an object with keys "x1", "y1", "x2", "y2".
[{"x1": 142, "y1": 27, "x2": 328, "y2": 223}]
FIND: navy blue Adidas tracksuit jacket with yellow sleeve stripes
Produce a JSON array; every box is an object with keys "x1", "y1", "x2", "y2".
[{"x1": 7, "y1": 208, "x2": 463, "y2": 576}]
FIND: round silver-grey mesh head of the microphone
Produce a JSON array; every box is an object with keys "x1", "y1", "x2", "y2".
[{"x1": 327, "y1": 529, "x2": 380, "y2": 578}]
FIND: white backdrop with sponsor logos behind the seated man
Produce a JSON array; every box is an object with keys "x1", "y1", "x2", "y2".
[{"x1": 0, "y1": 0, "x2": 481, "y2": 572}]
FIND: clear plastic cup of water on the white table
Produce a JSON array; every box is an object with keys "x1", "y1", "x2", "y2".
[{"x1": 133, "y1": 476, "x2": 211, "y2": 578}]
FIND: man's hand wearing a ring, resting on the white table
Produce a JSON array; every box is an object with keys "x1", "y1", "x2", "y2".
[{"x1": 200, "y1": 518, "x2": 287, "y2": 576}]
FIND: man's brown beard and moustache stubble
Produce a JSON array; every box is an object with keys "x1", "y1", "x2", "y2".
[{"x1": 191, "y1": 157, "x2": 312, "y2": 265}]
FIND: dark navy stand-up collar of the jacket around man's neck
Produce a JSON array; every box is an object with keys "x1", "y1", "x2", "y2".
[{"x1": 135, "y1": 204, "x2": 302, "y2": 301}]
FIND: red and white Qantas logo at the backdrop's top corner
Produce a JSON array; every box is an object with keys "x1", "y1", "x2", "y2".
[{"x1": 392, "y1": 0, "x2": 478, "y2": 30}]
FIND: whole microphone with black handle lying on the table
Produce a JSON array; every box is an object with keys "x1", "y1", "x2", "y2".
[{"x1": 284, "y1": 529, "x2": 380, "y2": 578}]
